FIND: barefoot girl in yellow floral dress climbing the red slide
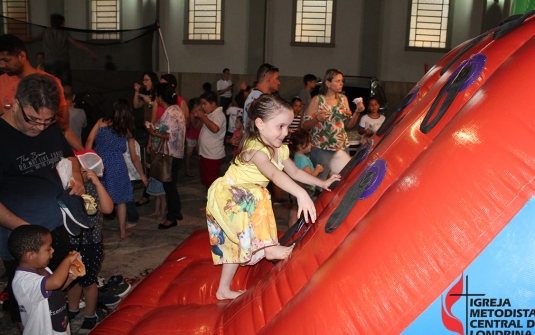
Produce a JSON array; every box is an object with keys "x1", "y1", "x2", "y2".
[{"x1": 206, "y1": 94, "x2": 340, "y2": 300}]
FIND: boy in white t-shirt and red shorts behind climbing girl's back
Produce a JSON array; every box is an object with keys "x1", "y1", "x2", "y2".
[{"x1": 196, "y1": 91, "x2": 227, "y2": 190}]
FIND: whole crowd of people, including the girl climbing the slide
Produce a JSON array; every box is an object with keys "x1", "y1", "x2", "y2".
[{"x1": 0, "y1": 27, "x2": 384, "y2": 333}]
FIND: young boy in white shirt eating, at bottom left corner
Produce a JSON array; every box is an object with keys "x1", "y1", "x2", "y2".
[{"x1": 8, "y1": 225, "x2": 79, "y2": 335}]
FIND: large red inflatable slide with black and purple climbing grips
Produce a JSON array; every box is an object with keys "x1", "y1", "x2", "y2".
[{"x1": 91, "y1": 13, "x2": 535, "y2": 335}]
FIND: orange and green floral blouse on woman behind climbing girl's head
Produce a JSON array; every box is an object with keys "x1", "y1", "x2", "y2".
[{"x1": 305, "y1": 94, "x2": 352, "y2": 151}]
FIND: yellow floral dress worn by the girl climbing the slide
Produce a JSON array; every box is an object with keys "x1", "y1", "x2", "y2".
[{"x1": 206, "y1": 141, "x2": 289, "y2": 265}]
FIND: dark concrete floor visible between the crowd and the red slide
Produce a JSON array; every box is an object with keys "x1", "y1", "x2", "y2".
[{"x1": 0, "y1": 148, "x2": 290, "y2": 335}]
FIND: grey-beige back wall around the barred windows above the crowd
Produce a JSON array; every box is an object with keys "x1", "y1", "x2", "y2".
[{"x1": 23, "y1": 0, "x2": 487, "y2": 82}]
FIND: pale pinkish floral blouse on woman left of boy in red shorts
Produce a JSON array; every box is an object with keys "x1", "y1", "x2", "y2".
[{"x1": 154, "y1": 105, "x2": 186, "y2": 158}]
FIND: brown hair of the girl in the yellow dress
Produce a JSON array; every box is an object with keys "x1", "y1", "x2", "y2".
[{"x1": 233, "y1": 94, "x2": 292, "y2": 164}]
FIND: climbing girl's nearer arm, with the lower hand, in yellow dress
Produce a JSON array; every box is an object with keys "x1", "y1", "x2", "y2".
[{"x1": 244, "y1": 150, "x2": 316, "y2": 222}]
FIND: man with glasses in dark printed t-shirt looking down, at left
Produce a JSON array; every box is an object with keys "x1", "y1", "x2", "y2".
[{"x1": 0, "y1": 74, "x2": 85, "y2": 330}]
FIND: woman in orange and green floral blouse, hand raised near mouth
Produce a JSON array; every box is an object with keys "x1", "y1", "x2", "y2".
[{"x1": 301, "y1": 69, "x2": 364, "y2": 179}]
